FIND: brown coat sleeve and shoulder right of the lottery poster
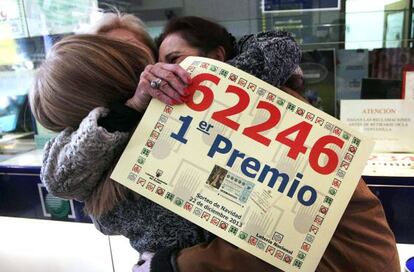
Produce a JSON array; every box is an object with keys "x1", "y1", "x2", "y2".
[{"x1": 317, "y1": 179, "x2": 400, "y2": 271}]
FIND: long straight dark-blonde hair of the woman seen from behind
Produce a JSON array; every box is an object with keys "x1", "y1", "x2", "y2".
[{"x1": 29, "y1": 35, "x2": 153, "y2": 216}]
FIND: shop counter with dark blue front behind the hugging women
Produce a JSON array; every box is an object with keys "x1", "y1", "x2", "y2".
[{"x1": 0, "y1": 149, "x2": 414, "y2": 244}]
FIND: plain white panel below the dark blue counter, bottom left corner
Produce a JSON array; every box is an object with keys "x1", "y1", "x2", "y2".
[{"x1": 0, "y1": 217, "x2": 139, "y2": 272}]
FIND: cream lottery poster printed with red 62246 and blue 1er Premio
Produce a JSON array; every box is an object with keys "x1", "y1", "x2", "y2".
[{"x1": 111, "y1": 57, "x2": 373, "y2": 271}]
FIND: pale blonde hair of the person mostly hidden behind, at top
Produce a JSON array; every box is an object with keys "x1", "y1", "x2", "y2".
[{"x1": 83, "y1": 9, "x2": 158, "y2": 59}]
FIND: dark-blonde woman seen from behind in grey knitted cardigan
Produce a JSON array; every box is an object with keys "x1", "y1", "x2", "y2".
[{"x1": 29, "y1": 35, "x2": 201, "y2": 252}]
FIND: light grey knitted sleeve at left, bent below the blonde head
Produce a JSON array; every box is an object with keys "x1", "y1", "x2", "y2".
[{"x1": 40, "y1": 108, "x2": 128, "y2": 201}]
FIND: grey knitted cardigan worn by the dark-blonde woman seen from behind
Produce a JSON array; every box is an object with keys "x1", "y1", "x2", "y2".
[{"x1": 41, "y1": 31, "x2": 301, "y2": 252}]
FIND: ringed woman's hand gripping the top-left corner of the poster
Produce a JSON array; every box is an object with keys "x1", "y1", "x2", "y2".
[{"x1": 126, "y1": 63, "x2": 191, "y2": 112}]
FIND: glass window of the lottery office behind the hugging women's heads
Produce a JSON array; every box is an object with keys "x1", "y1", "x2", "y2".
[{"x1": 0, "y1": 0, "x2": 414, "y2": 158}]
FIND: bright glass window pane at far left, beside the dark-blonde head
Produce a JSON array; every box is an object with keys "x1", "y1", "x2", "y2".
[{"x1": 0, "y1": 0, "x2": 98, "y2": 158}]
